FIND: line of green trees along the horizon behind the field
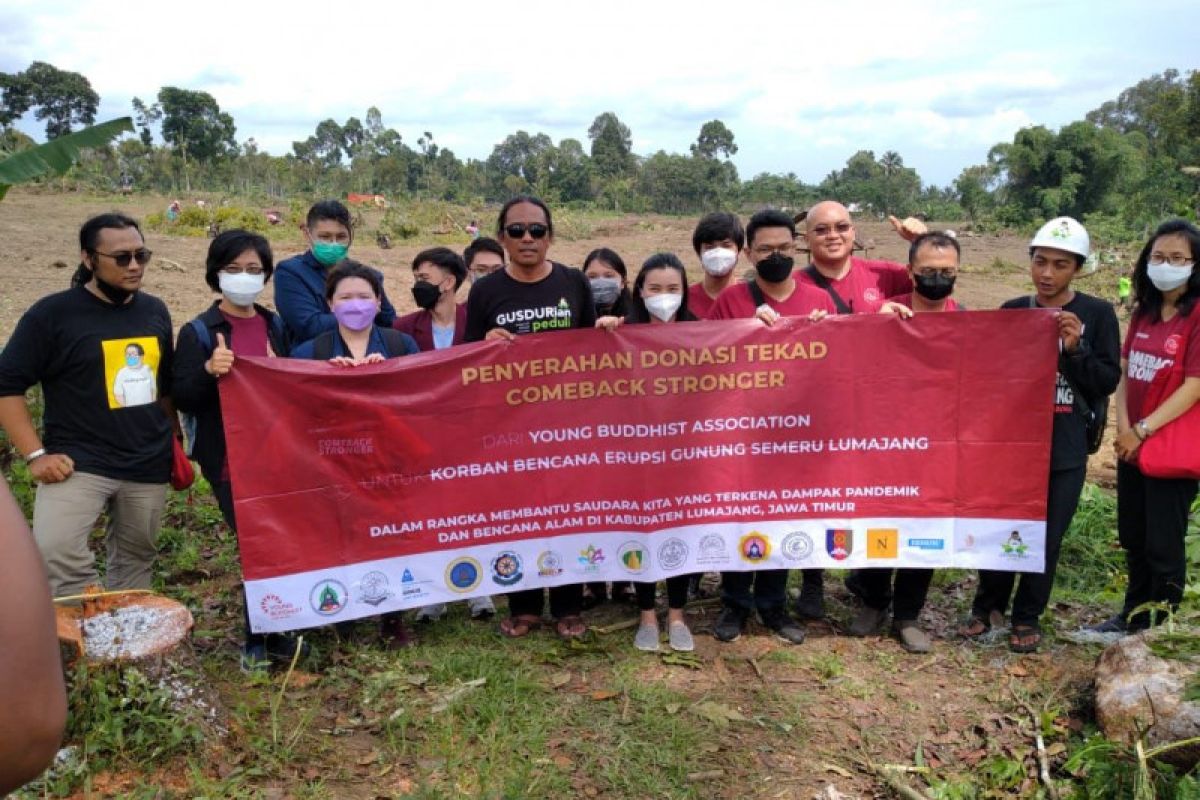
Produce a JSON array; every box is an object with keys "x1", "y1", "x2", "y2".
[{"x1": 0, "y1": 61, "x2": 1200, "y2": 235}]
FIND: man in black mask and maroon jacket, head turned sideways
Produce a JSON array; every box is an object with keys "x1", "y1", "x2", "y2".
[{"x1": 392, "y1": 247, "x2": 467, "y2": 353}]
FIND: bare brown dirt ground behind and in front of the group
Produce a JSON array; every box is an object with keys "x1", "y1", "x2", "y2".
[{"x1": 0, "y1": 191, "x2": 1111, "y2": 799}]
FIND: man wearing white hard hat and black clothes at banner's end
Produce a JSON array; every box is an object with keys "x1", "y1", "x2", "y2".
[{"x1": 961, "y1": 217, "x2": 1121, "y2": 652}]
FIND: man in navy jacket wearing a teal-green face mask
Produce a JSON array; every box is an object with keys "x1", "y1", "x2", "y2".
[{"x1": 275, "y1": 200, "x2": 396, "y2": 342}]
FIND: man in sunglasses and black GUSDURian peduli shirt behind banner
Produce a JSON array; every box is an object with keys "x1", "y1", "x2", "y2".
[{"x1": 467, "y1": 196, "x2": 596, "y2": 639}]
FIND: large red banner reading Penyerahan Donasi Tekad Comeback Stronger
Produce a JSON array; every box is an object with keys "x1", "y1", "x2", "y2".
[{"x1": 221, "y1": 311, "x2": 1057, "y2": 630}]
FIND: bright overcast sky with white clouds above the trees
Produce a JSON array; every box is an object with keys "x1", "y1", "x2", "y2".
[{"x1": 0, "y1": 0, "x2": 1200, "y2": 185}]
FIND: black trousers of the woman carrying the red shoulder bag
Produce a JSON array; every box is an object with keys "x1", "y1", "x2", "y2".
[{"x1": 1117, "y1": 460, "x2": 1200, "y2": 628}]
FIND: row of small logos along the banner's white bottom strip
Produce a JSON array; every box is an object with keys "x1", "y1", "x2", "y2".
[{"x1": 248, "y1": 528, "x2": 1030, "y2": 622}]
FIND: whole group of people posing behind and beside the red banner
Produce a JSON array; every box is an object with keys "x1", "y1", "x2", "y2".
[{"x1": 0, "y1": 196, "x2": 1200, "y2": 669}]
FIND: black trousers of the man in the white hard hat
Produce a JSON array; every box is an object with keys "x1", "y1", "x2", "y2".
[{"x1": 972, "y1": 464, "x2": 1089, "y2": 626}]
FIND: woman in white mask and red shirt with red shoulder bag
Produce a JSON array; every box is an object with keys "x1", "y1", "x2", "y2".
[{"x1": 1093, "y1": 219, "x2": 1200, "y2": 633}]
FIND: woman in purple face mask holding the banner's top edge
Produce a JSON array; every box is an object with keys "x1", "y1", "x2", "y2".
[{"x1": 292, "y1": 259, "x2": 420, "y2": 649}]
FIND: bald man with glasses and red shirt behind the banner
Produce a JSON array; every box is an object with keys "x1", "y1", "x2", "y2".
[{"x1": 796, "y1": 200, "x2": 925, "y2": 619}]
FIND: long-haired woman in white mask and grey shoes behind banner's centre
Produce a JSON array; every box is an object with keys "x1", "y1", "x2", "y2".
[{"x1": 596, "y1": 253, "x2": 696, "y2": 652}]
